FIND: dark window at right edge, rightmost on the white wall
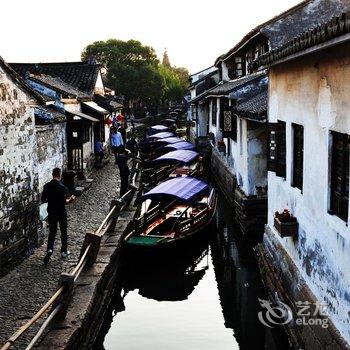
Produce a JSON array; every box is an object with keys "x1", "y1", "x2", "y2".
[{"x1": 329, "y1": 132, "x2": 349, "y2": 221}]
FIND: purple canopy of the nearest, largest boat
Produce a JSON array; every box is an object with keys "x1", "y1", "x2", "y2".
[{"x1": 138, "y1": 176, "x2": 209, "y2": 203}]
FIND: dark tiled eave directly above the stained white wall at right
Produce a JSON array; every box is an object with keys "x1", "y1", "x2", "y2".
[{"x1": 251, "y1": 12, "x2": 350, "y2": 69}]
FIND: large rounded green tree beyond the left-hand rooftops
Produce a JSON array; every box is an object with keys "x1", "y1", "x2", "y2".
[{"x1": 81, "y1": 39, "x2": 164, "y2": 110}]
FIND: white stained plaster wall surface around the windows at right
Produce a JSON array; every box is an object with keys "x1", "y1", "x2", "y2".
[{"x1": 267, "y1": 45, "x2": 350, "y2": 342}]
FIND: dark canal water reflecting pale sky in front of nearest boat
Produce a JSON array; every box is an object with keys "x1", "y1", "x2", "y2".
[{"x1": 94, "y1": 196, "x2": 289, "y2": 350}]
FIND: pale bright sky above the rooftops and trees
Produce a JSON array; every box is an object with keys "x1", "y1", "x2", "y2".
[{"x1": 0, "y1": 0, "x2": 300, "y2": 73}]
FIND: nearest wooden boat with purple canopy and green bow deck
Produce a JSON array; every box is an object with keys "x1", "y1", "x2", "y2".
[{"x1": 124, "y1": 176, "x2": 217, "y2": 251}]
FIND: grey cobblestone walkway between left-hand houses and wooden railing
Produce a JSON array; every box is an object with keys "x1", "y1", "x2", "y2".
[{"x1": 0, "y1": 163, "x2": 119, "y2": 349}]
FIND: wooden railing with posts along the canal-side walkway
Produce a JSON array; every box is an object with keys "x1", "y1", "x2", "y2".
[{"x1": 0, "y1": 162, "x2": 139, "y2": 350}]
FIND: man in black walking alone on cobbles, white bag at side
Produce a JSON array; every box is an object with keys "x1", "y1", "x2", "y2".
[{"x1": 41, "y1": 168, "x2": 75, "y2": 265}]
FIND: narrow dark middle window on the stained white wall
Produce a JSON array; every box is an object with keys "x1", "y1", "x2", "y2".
[{"x1": 292, "y1": 124, "x2": 304, "y2": 190}]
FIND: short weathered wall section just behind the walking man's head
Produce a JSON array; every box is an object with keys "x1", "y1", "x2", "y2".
[{"x1": 36, "y1": 123, "x2": 67, "y2": 192}]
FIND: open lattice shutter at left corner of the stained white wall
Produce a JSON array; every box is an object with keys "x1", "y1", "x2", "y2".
[{"x1": 267, "y1": 121, "x2": 286, "y2": 178}]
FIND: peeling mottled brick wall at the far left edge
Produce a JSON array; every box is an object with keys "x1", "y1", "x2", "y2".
[{"x1": 0, "y1": 68, "x2": 39, "y2": 268}]
